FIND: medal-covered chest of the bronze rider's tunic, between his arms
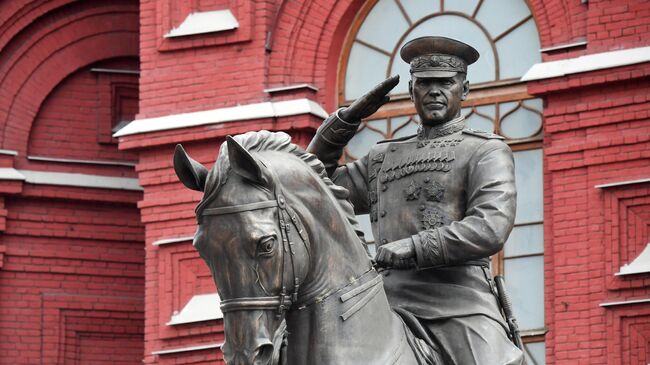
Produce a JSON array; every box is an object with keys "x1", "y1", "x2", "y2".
[{"x1": 368, "y1": 137, "x2": 467, "y2": 245}]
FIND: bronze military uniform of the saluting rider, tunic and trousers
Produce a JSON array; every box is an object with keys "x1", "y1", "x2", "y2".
[{"x1": 311, "y1": 114, "x2": 522, "y2": 364}]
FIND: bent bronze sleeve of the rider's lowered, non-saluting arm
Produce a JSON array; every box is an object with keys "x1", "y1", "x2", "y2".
[{"x1": 412, "y1": 139, "x2": 517, "y2": 269}]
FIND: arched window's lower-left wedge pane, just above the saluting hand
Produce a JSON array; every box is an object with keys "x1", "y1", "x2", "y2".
[{"x1": 345, "y1": 42, "x2": 390, "y2": 100}]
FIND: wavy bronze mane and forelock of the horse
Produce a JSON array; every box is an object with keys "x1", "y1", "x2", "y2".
[{"x1": 196, "y1": 130, "x2": 366, "y2": 247}]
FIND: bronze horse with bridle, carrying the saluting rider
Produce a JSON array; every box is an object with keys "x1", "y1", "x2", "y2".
[{"x1": 174, "y1": 131, "x2": 438, "y2": 365}]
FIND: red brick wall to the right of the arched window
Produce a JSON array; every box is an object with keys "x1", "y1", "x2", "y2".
[{"x1": 528, "y1": 1, "x2": 650, "y2": 364}]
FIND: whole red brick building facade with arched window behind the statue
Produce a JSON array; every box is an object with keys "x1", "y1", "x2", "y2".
[{"x1": 0, "y1": 0, "x2": 650, "y2": 364}]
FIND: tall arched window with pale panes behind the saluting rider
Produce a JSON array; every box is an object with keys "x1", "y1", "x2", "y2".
[{"x1": 338, "y1": 0, "x2": 546, "y2": 364}]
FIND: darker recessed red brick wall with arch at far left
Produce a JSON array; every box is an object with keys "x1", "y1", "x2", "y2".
[{"x1": 0, "y1": 0, "x2": 144, "y2": 364}]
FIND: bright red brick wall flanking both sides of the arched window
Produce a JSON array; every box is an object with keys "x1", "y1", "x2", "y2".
[{"x1": 120, "y1": 0, "x2": 650, "y2": 364}]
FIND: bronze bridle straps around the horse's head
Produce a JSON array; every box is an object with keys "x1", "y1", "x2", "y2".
[{"x1": 200, "y1": 187, "x2": 310, "y2": 317}]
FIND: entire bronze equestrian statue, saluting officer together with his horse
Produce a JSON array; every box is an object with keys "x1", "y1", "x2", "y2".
[{"x1": 174, "y1": 37, "x2": 524, "y2": 365}]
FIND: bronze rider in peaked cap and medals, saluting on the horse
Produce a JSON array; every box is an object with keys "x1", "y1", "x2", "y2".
[{"x1": 308, "y1": 37, "x2": 524, "y2": 365}]
